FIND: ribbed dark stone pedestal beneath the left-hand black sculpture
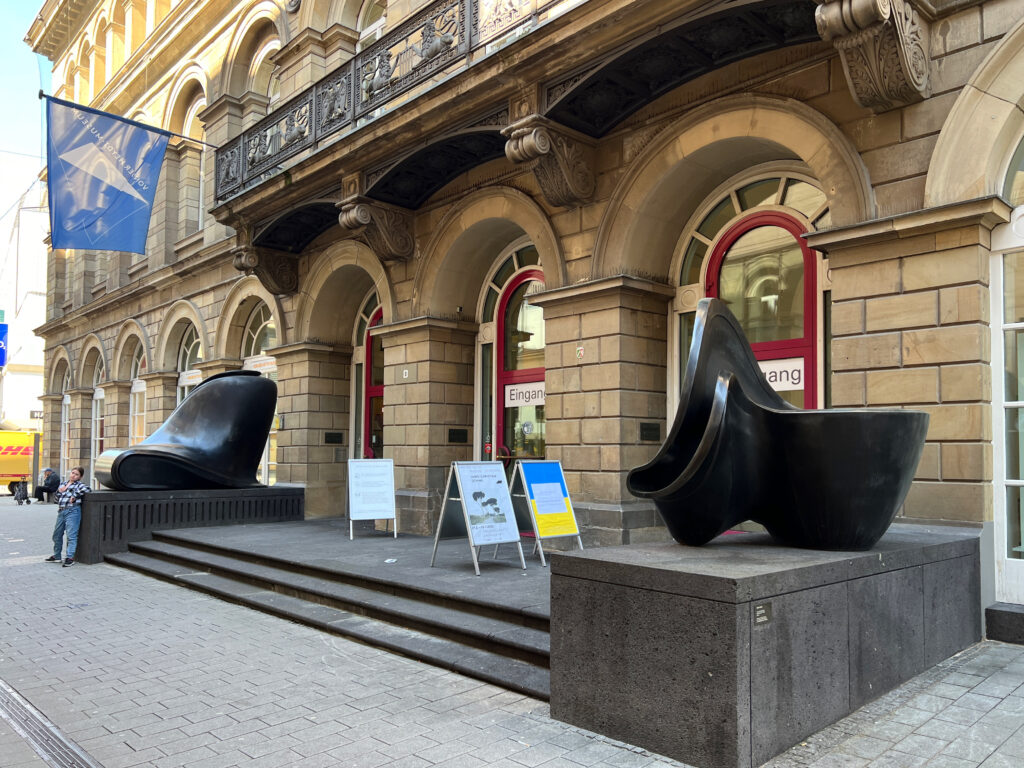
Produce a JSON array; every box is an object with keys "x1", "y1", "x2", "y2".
[{"x1": 75, "y1": 485, "x2": 305, "y2": 563}]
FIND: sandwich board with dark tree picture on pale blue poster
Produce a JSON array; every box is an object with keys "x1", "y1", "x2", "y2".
[{"x1": 430, "y1": 462, "x2": 526, "y2": 575}]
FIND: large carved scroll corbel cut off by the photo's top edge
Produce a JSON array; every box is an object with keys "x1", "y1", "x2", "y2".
[{"x1": 814, "y1": 0, "x2": 932, "y2": 113}]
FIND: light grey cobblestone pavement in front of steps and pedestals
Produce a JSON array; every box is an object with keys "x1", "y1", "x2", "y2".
[{"x1": 6, "y1": 497, "x2": 1024, "y2": 768}]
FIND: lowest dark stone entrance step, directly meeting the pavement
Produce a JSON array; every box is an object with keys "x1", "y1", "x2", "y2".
[{"x1": 106, "y1": 545, "x2": 550, "y2": 700}]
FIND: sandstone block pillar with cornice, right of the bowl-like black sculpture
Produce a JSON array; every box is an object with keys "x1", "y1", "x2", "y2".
[{"x1": 808, "y1": 199, "x2": 1010, "y2": 522}]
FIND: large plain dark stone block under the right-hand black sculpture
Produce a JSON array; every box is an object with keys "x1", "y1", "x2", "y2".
[{"x1": 551, "y1": 525, "x2": 981, "y2": 768}]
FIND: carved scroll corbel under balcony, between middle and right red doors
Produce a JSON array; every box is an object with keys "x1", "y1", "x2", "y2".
[{"x1": 502, "y1": 115, "x2": 597, "y2": 206}]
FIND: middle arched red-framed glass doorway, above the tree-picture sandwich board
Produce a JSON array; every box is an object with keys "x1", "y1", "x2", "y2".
[{"x1": 477, "y1": 244, "x2": 545, "y2": 463}]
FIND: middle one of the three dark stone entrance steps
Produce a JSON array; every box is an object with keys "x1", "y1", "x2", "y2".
[{"x1": 123, "y1": 541, "x2": 551, "y2": 667}]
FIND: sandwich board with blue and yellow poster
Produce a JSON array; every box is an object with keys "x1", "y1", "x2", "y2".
[{"x1": 511, "y1": 461, "x2": 583, "y2": 565}]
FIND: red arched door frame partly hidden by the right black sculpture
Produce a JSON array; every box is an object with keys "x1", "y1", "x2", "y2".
[{"x1": 706, "y1": 211, "x2": 818, "y2": 409}]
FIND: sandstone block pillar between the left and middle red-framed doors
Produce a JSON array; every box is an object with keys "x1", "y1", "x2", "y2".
[{"x1": 374, "y1": 317, "x2": 476, "y2": 535}]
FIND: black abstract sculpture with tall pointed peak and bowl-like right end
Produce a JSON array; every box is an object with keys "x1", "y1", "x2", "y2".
[{"x1": 627, "y1": 299, "x2": 928, "y2": 550}]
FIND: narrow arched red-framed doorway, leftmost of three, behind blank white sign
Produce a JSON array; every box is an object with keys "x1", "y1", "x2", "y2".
[{"x1": 352, "y1": 291, "x2": 384, "y2": 459}]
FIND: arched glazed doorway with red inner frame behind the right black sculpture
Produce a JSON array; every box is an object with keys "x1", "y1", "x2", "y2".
[{"x1": 670, "y1": 167, "x2": 830, "y2": 409}]
